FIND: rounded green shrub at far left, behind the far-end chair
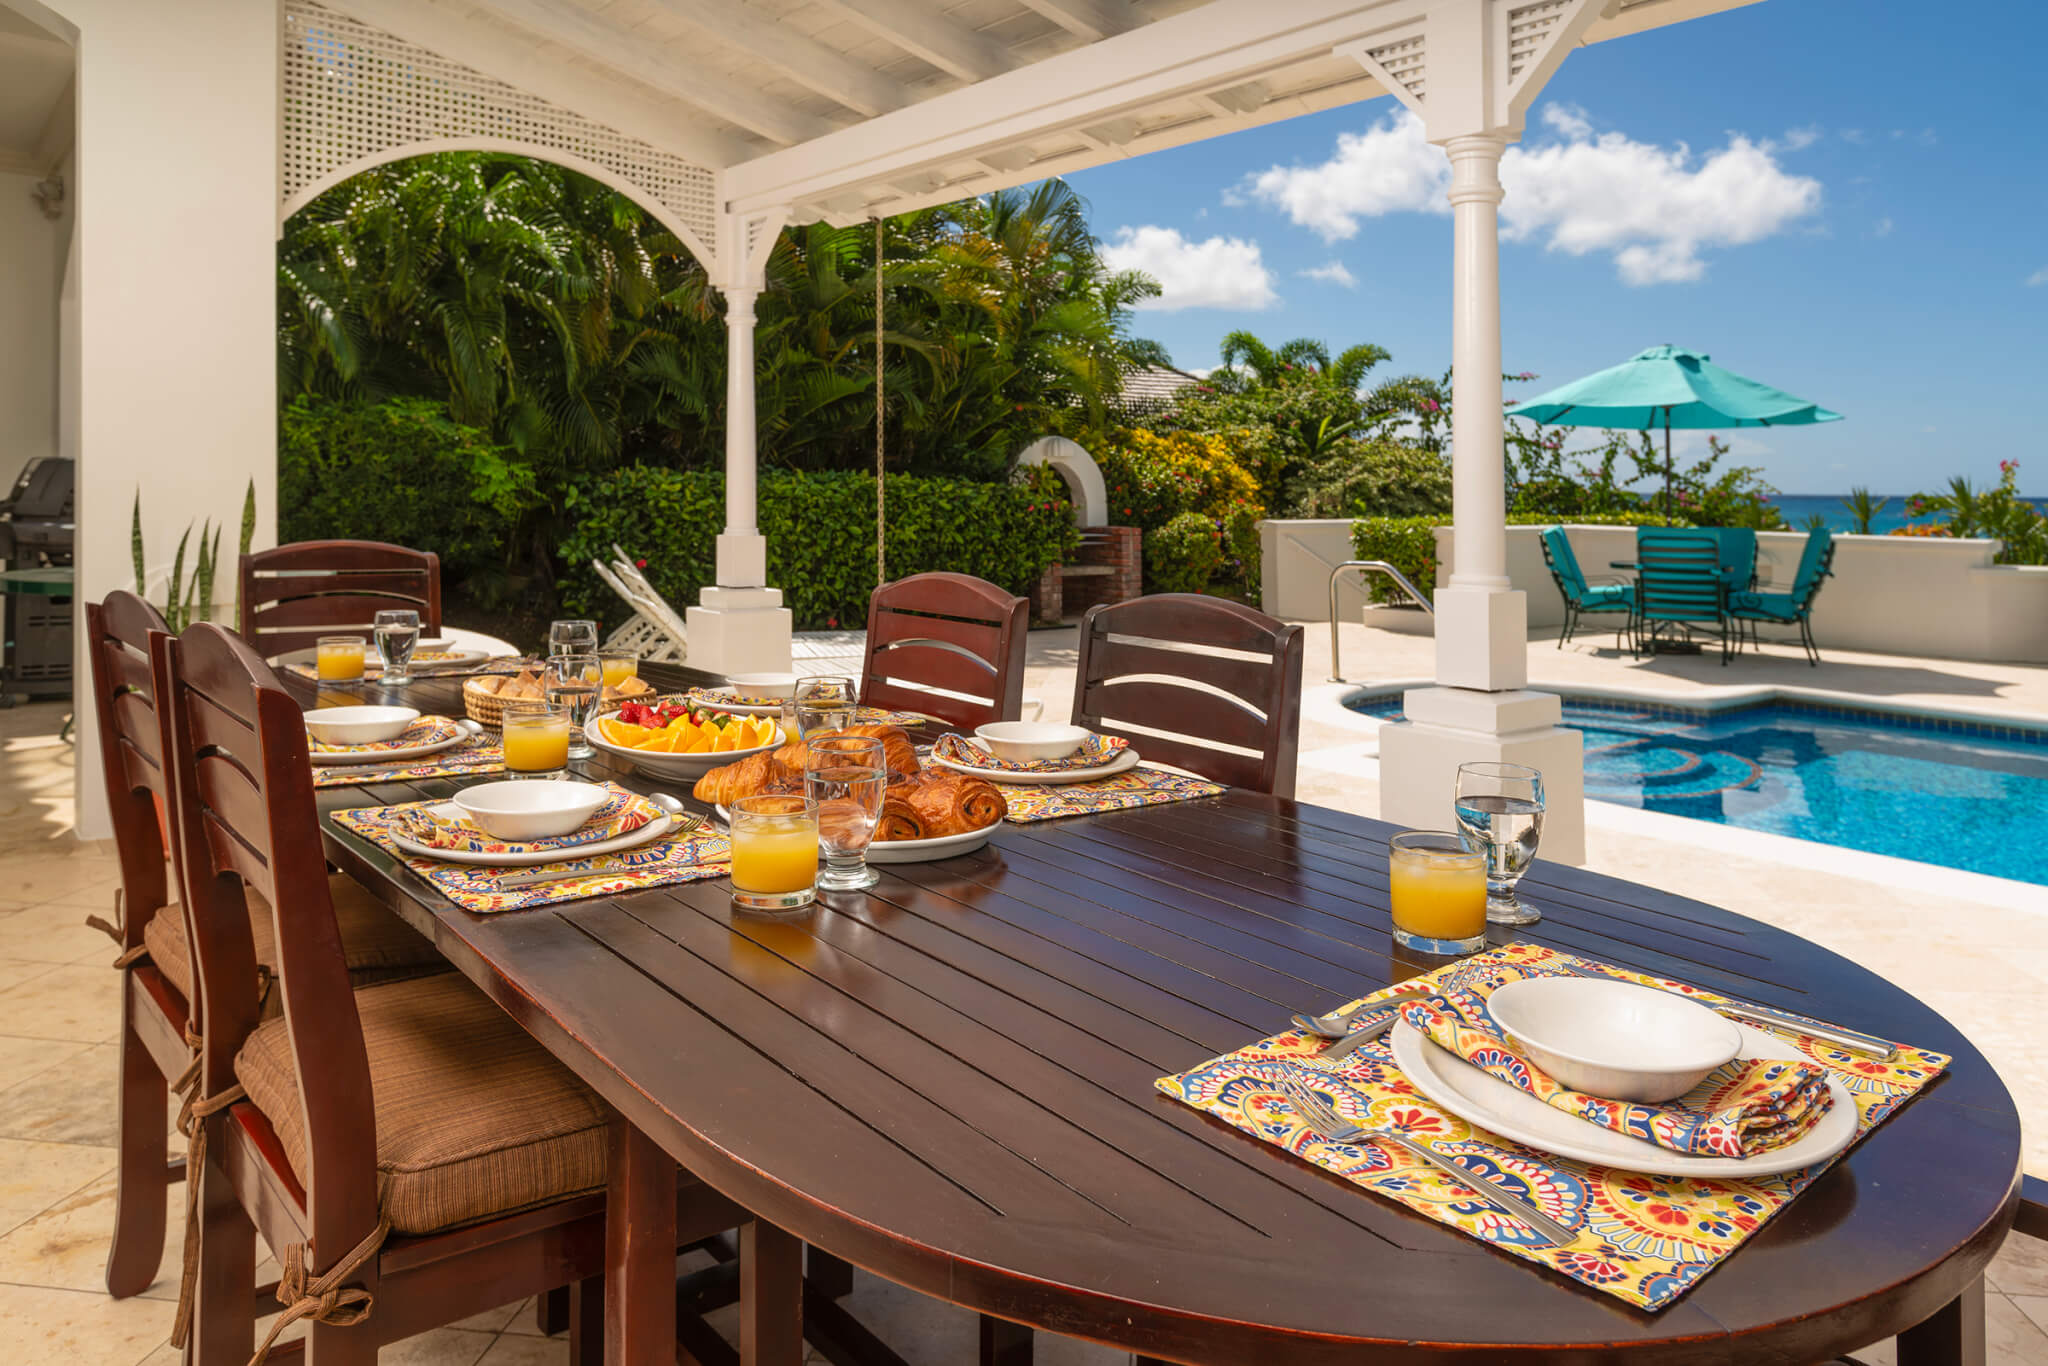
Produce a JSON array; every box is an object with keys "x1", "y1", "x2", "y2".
[{"x1": 276, "y1": 397, "x2": 537, "y2": 584}]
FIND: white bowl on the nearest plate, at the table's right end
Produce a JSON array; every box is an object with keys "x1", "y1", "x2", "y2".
[{"x1": 1487, "y1": 977, "x2": 1743, "y2": 1102}]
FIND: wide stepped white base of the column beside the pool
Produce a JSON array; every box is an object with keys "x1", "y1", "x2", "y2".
[{"x1": 1380, "y1": 684, "x2": 1585, "y2": 866}]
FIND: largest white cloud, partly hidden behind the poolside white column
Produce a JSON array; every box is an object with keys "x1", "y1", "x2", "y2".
[{"x1": 1245, "y1": 104, "x2": 1821, "y2": 285}]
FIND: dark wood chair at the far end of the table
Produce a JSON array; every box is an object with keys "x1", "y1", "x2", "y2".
[{"x1": 240, "y1": 541, "x2": 440, "y2": 659}]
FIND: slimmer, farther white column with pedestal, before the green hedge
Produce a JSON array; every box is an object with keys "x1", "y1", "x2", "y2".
[{"x1": 684, "y1": 268, "x2": 791, "y2": 674}]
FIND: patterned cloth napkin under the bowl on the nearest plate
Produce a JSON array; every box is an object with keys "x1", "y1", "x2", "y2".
[{"x1": 1401, "y1": 987, "x2": 1835, "y2": 1157}]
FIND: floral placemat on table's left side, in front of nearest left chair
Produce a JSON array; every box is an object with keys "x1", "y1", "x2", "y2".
[{"x1": 334, "y1": 801, "x2": 733, "y2": 911}]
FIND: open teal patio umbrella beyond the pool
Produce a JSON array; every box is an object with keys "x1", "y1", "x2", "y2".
[{"x1": 1507, "y1": 346, "x2": 1841, "y2": 518}]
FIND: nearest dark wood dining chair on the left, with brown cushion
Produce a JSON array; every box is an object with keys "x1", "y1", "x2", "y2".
[{"x1": 152, "y1": 625, "x2": 770, "y2": 1366}]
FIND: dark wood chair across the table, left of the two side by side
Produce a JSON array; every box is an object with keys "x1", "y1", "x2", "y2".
[{"x1": 860, "y1": 573, "x2": 1030, "y2": 731}]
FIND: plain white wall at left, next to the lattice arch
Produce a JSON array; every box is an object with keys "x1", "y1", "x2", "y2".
[{"x1": 28, "y1": 0, "x2": 279, "y2": 840}]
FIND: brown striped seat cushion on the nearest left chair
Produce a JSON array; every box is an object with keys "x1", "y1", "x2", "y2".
[{"x1": 236, "y1": 973, "x2": 606, "y2": 1233}]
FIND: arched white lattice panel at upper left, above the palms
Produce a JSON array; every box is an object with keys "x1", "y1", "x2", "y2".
[{"x1": 283, "y1": 0, "x2": 717, "y2": 266}]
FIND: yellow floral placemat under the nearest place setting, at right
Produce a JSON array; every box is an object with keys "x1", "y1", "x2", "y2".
[{"x1": 1157, "y1": 944, "x2": 1950, "y2": 1311}]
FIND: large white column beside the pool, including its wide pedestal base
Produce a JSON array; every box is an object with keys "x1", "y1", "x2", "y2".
[{"x1": 1376, "y1": 133, "x2": 1585, "y2": 864}]
